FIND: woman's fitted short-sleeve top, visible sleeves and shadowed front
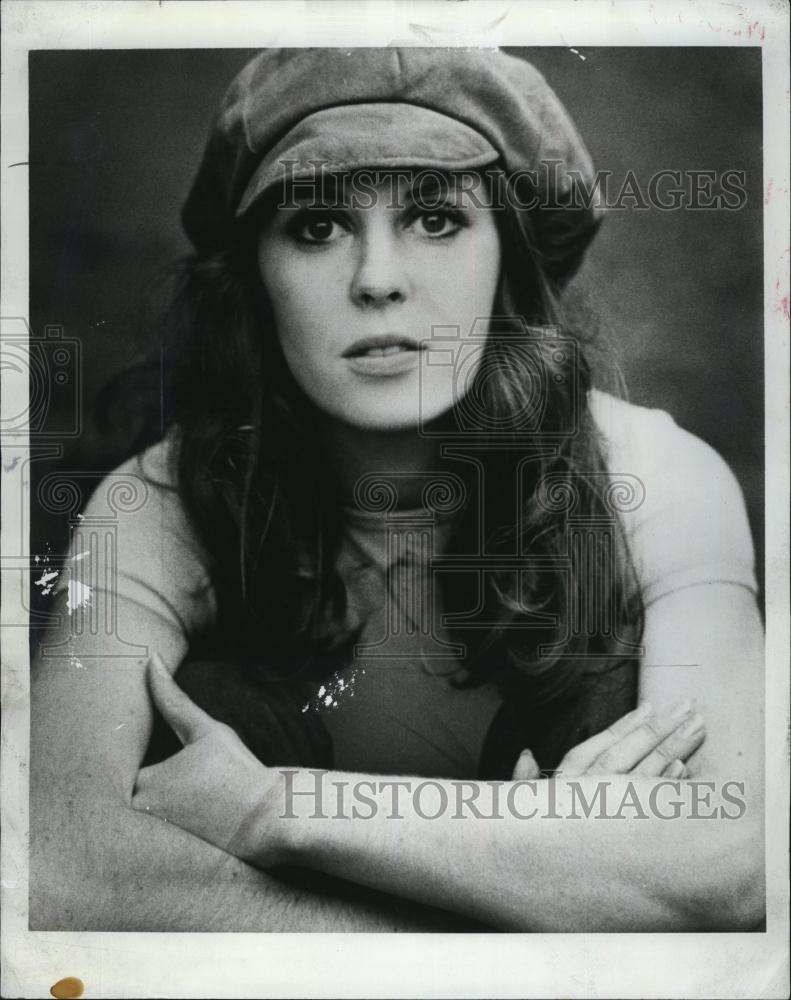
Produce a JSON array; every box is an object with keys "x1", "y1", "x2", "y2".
[{"x1": 58, "y1": 390, "x2": 757, "y2": 777}]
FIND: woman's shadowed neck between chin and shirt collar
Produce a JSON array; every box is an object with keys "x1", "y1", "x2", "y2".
[{"x1": 318, "y1": 419, "x2": 452, "y2": 509}]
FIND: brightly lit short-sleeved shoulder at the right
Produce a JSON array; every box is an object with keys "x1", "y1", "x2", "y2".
[{"x1": 589, "y1": 390, "x2": 757, "y2": 603}]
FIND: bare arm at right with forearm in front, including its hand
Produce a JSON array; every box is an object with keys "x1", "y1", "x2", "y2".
[{"x1": 139, "y1": 586, "x2": 763, "y2": 932}]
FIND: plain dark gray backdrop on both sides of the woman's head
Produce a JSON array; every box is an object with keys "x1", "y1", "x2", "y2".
[{"x1": 29, "y1": 48, "x2": 763, "y2": 600}]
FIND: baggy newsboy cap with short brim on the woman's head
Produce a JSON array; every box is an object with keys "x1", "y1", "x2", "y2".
[{"x1": 182, "y1": 47, "x2": 600, "y2": 282}]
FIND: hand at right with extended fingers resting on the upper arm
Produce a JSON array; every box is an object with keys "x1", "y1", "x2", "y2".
[{"x1": 512, "y1": 702, "x2": 706, "y2": 781}]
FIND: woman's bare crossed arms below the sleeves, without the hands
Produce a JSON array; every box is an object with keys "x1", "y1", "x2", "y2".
[{"x1": 30, "y1": 584, "x2": 763, "y2": 931}]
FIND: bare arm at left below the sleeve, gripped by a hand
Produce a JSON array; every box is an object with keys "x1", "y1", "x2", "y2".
[{"x1": 30, "y1": 576, "x2": 476, "y2": 931}]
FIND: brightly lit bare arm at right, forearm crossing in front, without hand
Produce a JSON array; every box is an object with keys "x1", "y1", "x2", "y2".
[{"x1": 296, "y1": 584, "x2": 764, "y2": 931}]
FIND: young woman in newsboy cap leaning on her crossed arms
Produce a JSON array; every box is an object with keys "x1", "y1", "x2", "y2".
[{"x1": 31, "y1": 49, "x2": 763, "y2": 931}]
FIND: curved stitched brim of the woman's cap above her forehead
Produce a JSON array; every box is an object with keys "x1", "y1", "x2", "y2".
[{"x1": 236, "y1": 102, "x2": 499, "y2": 216}]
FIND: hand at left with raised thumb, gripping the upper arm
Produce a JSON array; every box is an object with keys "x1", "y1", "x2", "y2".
[{"x1": 132, "y1": 653, "x2": 285, "y2": 868}]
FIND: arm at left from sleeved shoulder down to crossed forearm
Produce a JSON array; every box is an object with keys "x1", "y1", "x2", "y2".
[{"x1": 29, "y1": 441, "x2": 488, "y2": 931}]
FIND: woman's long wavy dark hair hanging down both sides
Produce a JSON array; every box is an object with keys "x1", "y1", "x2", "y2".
[{"x1": 105, "y1": 172, "x2": 642, "y2": 705}]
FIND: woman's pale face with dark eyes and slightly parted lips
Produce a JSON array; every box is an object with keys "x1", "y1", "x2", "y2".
[{"x1": 258, "y1": 174, "x2": 501, "y2": 430}]
